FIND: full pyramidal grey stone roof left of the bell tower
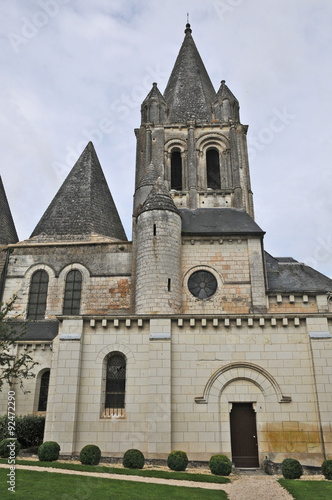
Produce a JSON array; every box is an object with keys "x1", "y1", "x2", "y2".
[{"x1": 31, "y1": 142, "x2": 127, "y2": 241}]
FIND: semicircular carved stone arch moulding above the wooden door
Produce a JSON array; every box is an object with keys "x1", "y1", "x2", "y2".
[{"x1": 195, "y1": 361, "x2": 291, "y2": 404}]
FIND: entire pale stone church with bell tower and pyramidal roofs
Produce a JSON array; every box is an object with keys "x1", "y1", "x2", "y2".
[{"x1": 0, "y1": 24, "x2": 332, "y2": 467}]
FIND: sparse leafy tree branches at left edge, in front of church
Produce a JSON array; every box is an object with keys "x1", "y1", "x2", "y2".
[{"x1": 0, "y1": 296, "x2": 38, "y2": 392}]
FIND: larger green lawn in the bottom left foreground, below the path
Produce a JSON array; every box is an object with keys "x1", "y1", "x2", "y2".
[{"x1": 0, "y1": 469, "x2": 227, "y2": 500}]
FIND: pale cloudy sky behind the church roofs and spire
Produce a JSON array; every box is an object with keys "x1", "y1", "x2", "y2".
[{"x1": 0, "y1": 0, "x2": 332, "y2": 277}]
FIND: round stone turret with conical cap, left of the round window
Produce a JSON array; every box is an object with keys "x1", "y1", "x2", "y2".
[{"x1": 135, "y1": 178, "x2": 182, "y2": 314}]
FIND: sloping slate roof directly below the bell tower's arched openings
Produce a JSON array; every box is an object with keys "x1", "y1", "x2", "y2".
[{"x1": 179, "y1": 208, "x2": 265, "y2": 236}]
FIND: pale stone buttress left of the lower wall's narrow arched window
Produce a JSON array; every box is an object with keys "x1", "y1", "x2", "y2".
[{"x1": 44, "y1": 319, "x2": 83, "y2": 455}]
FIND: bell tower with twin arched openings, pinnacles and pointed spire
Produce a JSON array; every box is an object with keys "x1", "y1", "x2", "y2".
[{"x1": 134, "y1": 23, "x2": 254, "y2": 217}]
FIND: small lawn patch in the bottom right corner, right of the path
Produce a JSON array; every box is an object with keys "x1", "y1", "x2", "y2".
[{"x1": 279, "y1": 479, "x2": 332, "y2": 500}]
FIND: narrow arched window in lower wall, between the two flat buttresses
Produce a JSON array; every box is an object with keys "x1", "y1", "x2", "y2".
[{"x1": 105, "y1": 353, "x2": 126, "y2": 415}]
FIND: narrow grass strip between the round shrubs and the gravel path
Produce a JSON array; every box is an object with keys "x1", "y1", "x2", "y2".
[{"x1": 0, "y1": 459, "x2": 230, "y2": 484}]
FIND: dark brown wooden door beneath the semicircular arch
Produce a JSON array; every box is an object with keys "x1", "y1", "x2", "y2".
[{"x1": 230, "y1": 403, "x2": 259, "y2": 468}]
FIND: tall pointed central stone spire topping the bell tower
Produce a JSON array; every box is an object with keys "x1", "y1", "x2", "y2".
[{"x1": 164, "y1": 24, "x2": 216, "y2": 123}]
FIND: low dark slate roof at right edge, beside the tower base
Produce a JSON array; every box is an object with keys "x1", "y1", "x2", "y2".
[{"x1": 265, "y1": 252, "x2": 332, "y2": 293}]
